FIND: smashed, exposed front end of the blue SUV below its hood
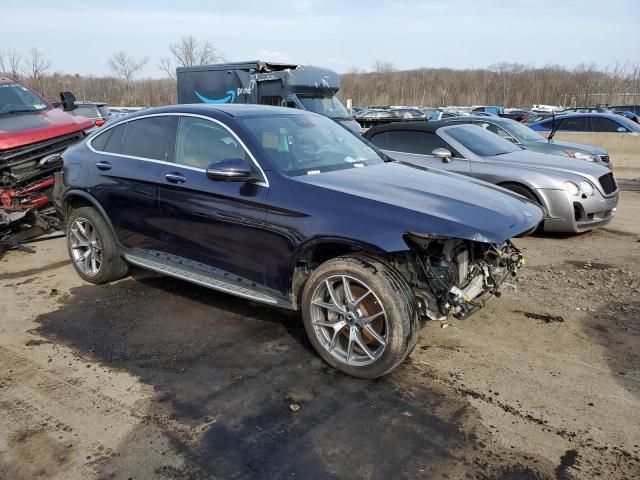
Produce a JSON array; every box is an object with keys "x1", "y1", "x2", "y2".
[{"x1": 396, "y1": 232, "x2": 525, "y2": 320}]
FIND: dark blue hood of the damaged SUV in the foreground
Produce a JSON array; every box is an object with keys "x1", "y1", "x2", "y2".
[{"x1": 294, "y1": 162, "x2": 544, "y2": 244}]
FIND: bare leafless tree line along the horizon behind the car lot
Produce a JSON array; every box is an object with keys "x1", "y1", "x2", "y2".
[{"x1": 0, "y1": 36, "x2": 640, "y2": 107}]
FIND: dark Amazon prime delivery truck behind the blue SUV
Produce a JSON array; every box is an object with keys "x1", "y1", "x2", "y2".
[{"x1": 176, "y1": 60, "x2": 361, "y2": 134}]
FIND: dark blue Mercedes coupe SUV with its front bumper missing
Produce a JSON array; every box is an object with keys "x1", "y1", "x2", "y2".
[{"x1": 54, "y1": 104, "x2": 543, "y2": 378}]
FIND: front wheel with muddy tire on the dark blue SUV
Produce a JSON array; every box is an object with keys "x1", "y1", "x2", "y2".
[{"x1": 302, "y1": 256, "x2": 420, "y2": 378}]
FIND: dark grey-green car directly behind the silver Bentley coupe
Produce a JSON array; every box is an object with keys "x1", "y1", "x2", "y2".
[{"x1": 440, "y1": 117, "x2": 611, "y2": 168}]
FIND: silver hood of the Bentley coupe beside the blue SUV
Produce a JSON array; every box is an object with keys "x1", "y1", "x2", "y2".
[{"x1": 483, "y1": 150, "x2": 611, "y2": 184}]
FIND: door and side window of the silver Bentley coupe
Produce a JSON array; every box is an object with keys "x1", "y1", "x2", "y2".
[{"x1": 370, "y1": 130, "x2": 469, "y2": 174}]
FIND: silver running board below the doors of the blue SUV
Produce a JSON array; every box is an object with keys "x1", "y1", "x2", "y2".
[{"x1": 124, "y1": 252, "x2": 292, "y2": 308}]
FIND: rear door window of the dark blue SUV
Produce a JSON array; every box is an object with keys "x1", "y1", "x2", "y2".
[{"x1": 121, "y1": 116, "x2": 174, "y2": 161}]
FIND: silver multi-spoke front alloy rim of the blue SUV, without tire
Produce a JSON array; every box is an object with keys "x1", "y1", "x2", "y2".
[{"x1": 311, "y1": 275, "x2": 389, "y2": 366}]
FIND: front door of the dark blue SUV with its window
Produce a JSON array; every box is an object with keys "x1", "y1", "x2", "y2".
[{"x1": 159, "y1": 116, "x2": 268, "y2": 285}]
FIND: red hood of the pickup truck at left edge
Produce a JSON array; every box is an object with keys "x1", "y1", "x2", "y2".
[{"x1": 0, "y1": 108, "x2": 93, "y2": 151}]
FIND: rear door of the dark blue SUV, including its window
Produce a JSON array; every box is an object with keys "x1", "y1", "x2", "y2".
[{"x1": 90, "y1": 115, "x2": 176, "y2": 248}]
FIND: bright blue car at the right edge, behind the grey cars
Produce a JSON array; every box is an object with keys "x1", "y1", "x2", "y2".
[{"x1": 529, "y1": 113, "x2": 640, "y2": 133}]
